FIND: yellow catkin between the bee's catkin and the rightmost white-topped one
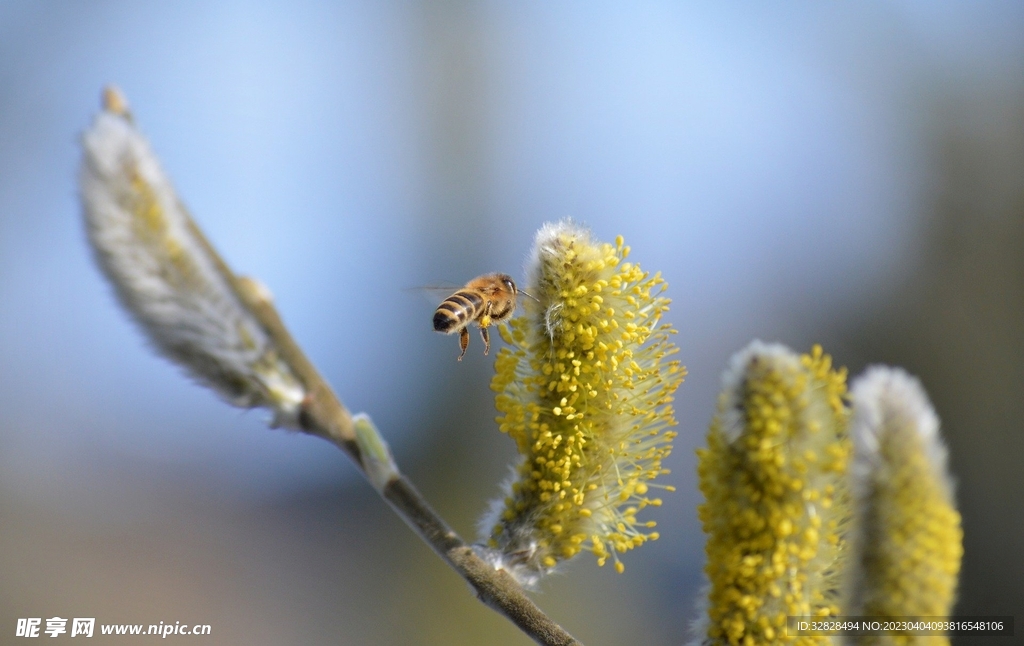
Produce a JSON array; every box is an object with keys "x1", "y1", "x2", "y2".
[{"x1": 697, "y1": 342, "x2": 850, "y2": 644}]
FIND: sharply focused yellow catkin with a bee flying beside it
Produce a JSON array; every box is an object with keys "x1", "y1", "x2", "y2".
[{"x1": 485, "y1": 222, "x2": 685, "y2": 585}]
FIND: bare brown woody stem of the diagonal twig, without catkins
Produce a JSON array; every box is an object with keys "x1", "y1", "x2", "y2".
[{"x1": 235, "y1": 274, "x2": 582, "y2": 646}]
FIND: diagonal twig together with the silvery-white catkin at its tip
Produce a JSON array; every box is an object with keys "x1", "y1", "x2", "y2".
[{"x1": 79, "y1": 88, "x2": 580, "y2": 646}]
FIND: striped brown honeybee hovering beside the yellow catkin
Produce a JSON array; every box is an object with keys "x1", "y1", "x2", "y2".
[{"x1": 434, "y1": 273, "x2": 532, "y2": 361}]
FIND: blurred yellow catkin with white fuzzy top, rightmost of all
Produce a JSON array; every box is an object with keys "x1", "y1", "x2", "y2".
[{"x1": 850, "y1": 367, "x2": 963, "y2": 644}]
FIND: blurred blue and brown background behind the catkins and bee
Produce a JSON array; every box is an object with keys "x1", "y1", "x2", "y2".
[{"x1": 0, "y1": 0, "x2": 1024, "y2": 645}]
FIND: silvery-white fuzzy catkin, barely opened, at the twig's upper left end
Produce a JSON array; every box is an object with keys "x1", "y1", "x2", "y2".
[{"x1": 79, "y1": 89, "x2": 305, "y2": 427}]
